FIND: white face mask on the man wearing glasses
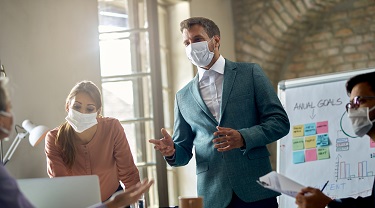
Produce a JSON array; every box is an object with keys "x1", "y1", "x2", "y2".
[{"x1": 348, "y1": 106, "x2": 375, "y2": 137}]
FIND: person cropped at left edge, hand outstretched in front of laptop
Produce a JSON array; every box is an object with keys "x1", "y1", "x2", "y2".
[{"x1": 0, "y1": 78, "x2": 154, "y2": 208}]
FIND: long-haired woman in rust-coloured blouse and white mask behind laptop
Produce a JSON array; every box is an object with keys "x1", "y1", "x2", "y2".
[{"x1": 45, "y1": 80, "x2": 140, "y2": 201}]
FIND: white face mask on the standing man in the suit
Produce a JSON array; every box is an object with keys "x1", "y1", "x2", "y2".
[{"x1": 185, "y1": 39, "x2": 215, "y2": 67}]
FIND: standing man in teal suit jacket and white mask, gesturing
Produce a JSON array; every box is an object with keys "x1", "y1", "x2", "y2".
[{"x1": 150, "y1": 17, "x2": 290, "y2": 208}]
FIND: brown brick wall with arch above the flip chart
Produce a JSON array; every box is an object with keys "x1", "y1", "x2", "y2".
[{"x1": 232, "y1": 0, "x2": 375, "y2": 87}]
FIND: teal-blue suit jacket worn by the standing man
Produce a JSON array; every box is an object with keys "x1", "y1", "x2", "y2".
[{"x1": 167, "y1": 60, "x2": 289, "y2": 208}]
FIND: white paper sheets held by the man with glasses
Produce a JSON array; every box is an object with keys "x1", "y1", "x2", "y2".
[{"x1": 257, "y1": 171, "x2": 305, "y2": 198}]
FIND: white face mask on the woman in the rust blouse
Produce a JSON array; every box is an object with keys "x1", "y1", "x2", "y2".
[{"x1": 65, "y1": 108, "x2": 98, "y2": 133}]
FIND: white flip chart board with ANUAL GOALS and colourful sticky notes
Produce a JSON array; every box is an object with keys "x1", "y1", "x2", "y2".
[{"x1": 277, "y1": 69, "x2": 375, "y2": 208}]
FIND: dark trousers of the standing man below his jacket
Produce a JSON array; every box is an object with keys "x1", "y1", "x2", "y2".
[{"x1": 227, "y1": 192, "x2": 279, "y2": 208}]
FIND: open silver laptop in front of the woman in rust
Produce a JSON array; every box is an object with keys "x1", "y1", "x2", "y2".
[{"x1": 17, "y1": 175, "x2": 101, "y2": 208}]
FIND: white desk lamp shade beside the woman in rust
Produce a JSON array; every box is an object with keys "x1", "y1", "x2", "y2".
[{"x1": 22, "y1": 120, "x2": 49, "y2": 147}]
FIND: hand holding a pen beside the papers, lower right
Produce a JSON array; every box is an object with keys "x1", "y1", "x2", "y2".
[{"x1": 296, "y1": 181, "x2": 332, "y2": 208}]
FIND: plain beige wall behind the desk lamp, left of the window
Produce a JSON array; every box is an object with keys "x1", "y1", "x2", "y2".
[{"x1": 0, "y1": 0, "x2": 101, "y2": 178}]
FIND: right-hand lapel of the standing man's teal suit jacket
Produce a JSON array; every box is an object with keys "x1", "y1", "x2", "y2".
[{"x1": 220, "y1": 59, "x2": 237, "y2": 120}]
